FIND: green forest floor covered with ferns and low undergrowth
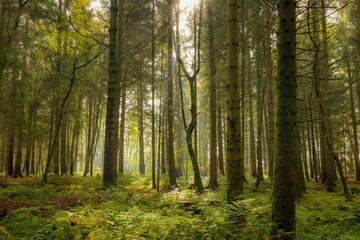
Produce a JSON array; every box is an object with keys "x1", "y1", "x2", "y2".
[{"x1": 0, "y1": 175, "x2": 360, "y2": 240}]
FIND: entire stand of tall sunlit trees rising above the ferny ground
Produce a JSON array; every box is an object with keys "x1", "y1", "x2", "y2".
[{"x1": 0, "y1": 0, "x2": 360, "y2": 239}]
